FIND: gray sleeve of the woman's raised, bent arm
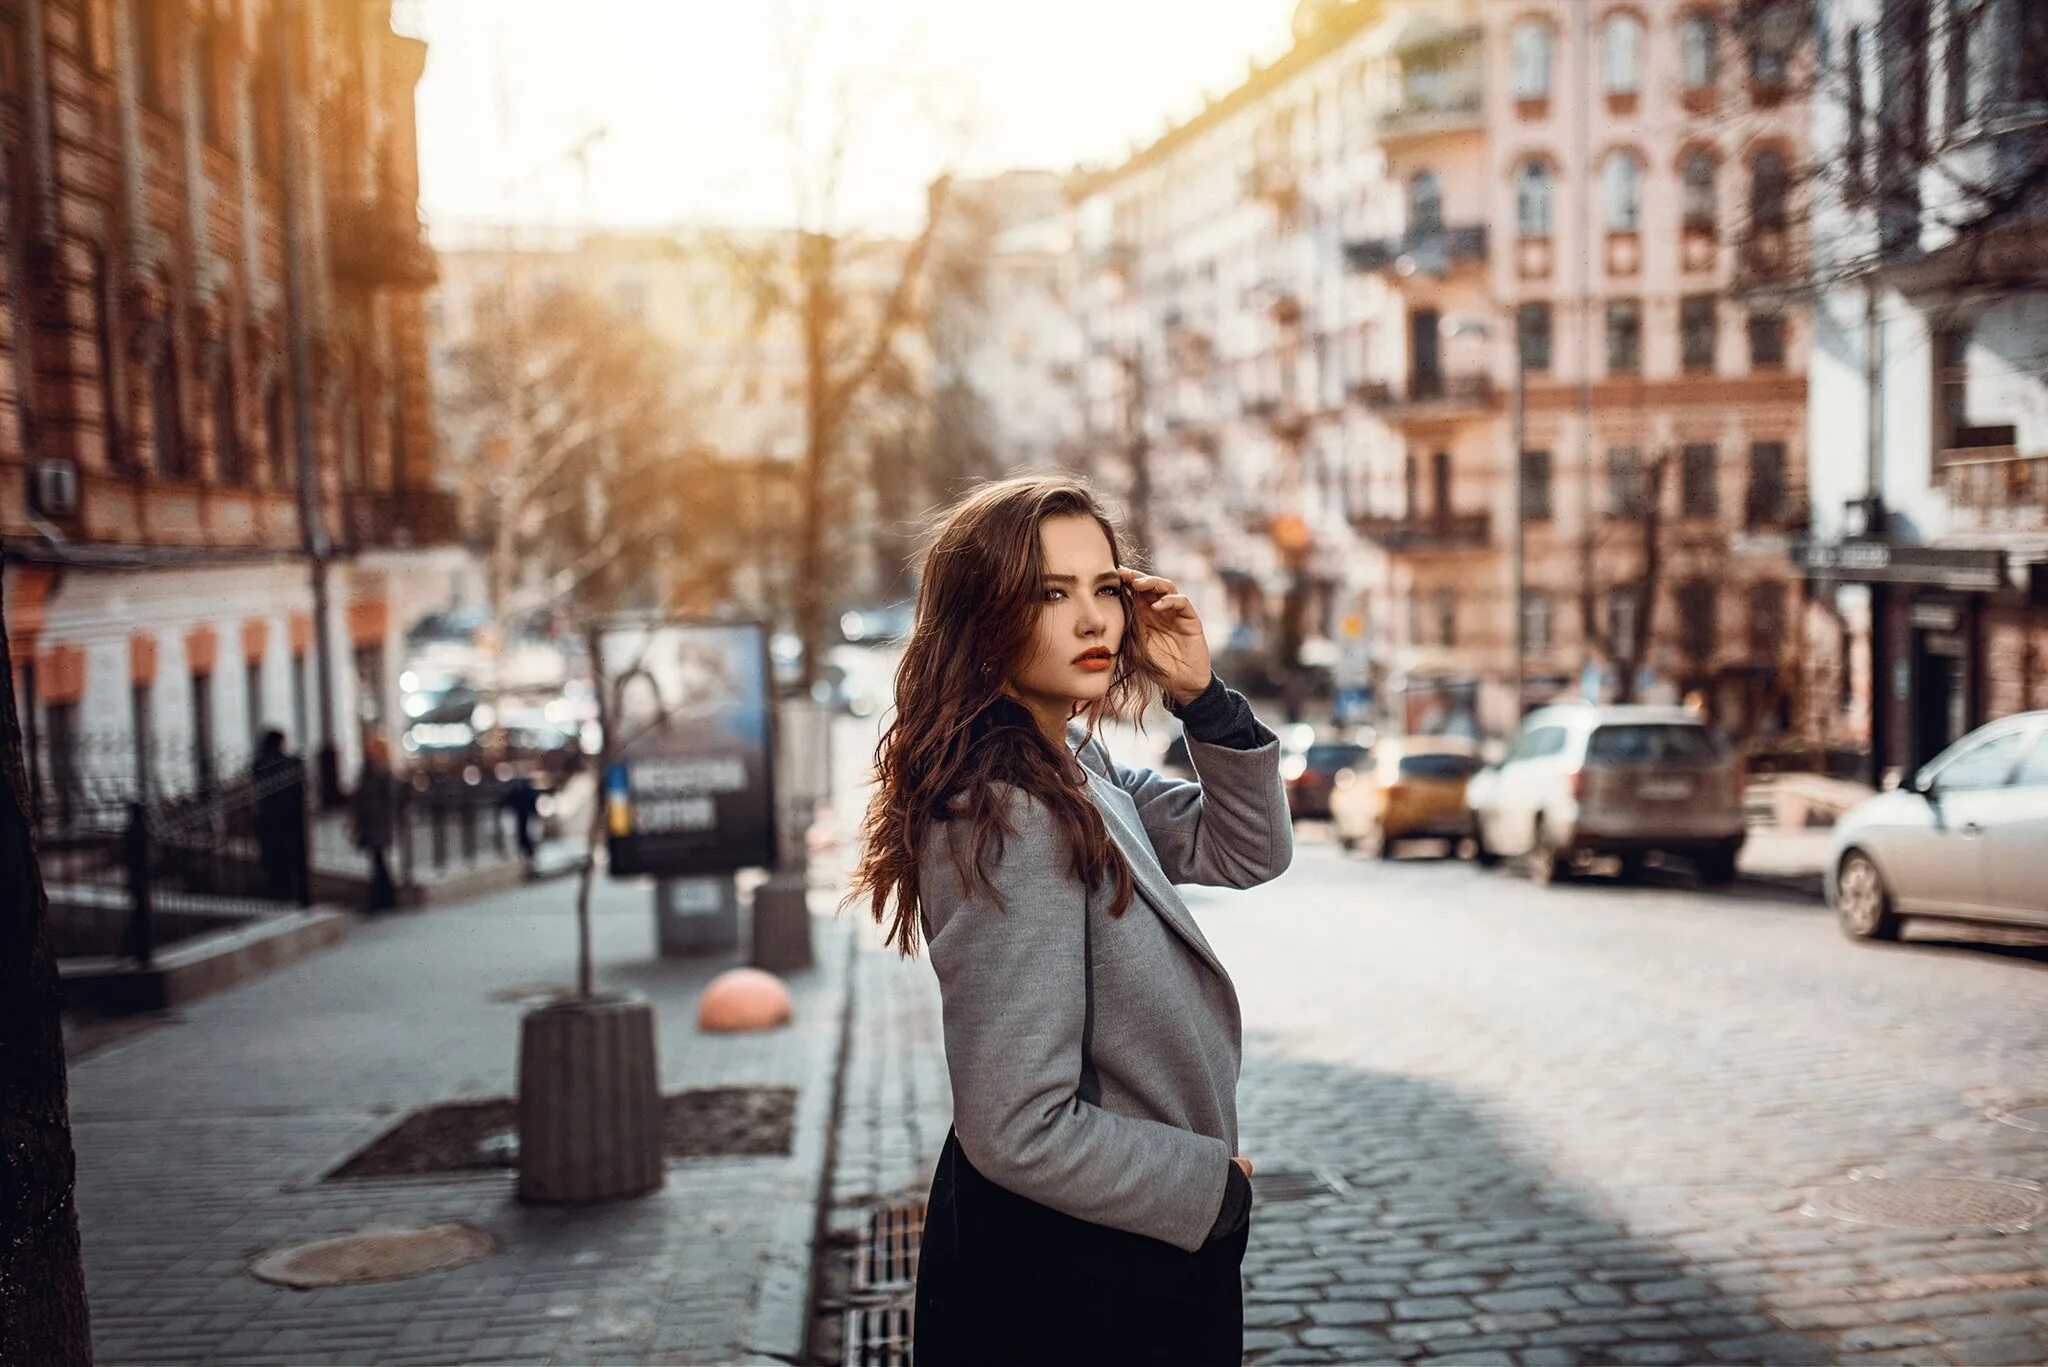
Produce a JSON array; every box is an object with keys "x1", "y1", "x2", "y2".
[{"x1": 1098, "y1": 719, "x2": 1294, "y2": 887}]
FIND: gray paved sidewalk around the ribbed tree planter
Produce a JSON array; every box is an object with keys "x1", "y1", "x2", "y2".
[{"x1": 72, "y1": 879, "x2": 854, "y2": 1363}]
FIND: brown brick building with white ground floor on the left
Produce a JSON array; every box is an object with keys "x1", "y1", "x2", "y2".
[{"x1": 0, "y1": 0, "x2": 467, "y2": 810}]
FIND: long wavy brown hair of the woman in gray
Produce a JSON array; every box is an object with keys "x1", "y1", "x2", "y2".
[{"x1": 840, "y1": 475, "x2": 1163, "y2": 955}]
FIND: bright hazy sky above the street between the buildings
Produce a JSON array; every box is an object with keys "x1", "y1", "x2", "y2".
[{"x1": 414, "y1": 0, "x2": 1294, "y2": 225}]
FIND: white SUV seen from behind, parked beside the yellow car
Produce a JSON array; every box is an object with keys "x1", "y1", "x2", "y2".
[{"x1": 1466, "y1": 703, "x2": 1745, "y2": 885}]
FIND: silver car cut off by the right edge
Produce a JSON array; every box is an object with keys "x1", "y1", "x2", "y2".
[{"x1": 1827, "y1": 711, "x2": 2048, "y2": 939}]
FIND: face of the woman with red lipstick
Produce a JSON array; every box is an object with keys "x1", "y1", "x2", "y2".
[{"x1": 1010, "y1": 512, "x2": 1124, "y2": 711}]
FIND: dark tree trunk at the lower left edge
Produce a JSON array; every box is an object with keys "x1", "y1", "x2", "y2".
[{"x1": 0, "y1": 541, "x2": 92, "y2": 1365}]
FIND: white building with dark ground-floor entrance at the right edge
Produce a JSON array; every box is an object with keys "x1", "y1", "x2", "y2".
[{"x1": 1794, "y1": 0, "x2": 2048, "y2": 779}]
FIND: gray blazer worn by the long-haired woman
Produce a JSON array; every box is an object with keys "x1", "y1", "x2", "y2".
[{"x1": 918, "y1": 723, "x2": 1294, "y2": 1252}]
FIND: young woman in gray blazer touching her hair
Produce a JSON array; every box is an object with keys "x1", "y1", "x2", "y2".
[{"x1": 850, "y1": 478, "x2": 1294, "y2": 1367}]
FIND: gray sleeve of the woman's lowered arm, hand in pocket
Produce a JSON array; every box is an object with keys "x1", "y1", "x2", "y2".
[{"x1": 924, "y1": 791, "x2": 1231, "y2": 1252}]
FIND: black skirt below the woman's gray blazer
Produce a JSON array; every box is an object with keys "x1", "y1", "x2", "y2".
[{"x1": 915, "y1": 1131, "x2": 1249, "y2": 1367}]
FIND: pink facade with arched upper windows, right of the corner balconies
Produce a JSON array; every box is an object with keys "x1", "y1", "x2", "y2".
[{"x1": 1483, "y1": 0, "x2": 1810, "y2": 736}]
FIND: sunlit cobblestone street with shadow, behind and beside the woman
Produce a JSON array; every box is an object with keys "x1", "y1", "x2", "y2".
[{"x1": 834, "y1": 791, "x2": 2048, "y2": 1365}]
